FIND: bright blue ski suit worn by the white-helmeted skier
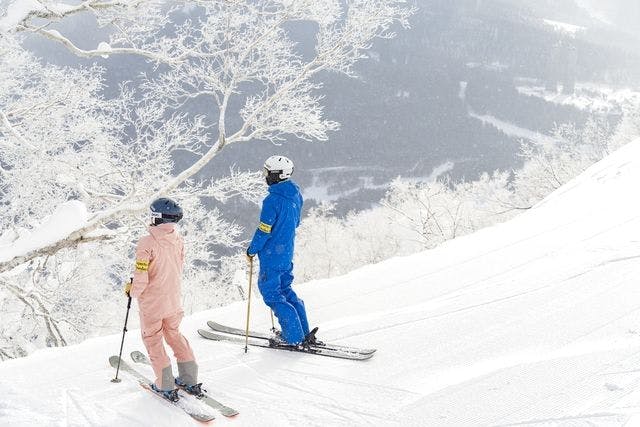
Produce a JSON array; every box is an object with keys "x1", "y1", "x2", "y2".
[{"x1": 247, "y1": 180, "x2": 309, "y2": 344}]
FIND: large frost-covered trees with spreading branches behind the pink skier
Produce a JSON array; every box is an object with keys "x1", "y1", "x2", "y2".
[{"x1": 0, "y1": 0, "x2": 412, "y2": 357}]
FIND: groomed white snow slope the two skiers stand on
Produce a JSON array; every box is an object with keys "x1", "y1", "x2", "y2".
[{"x1": 0, "y1": 140, "x2": 640, "y2": 426}]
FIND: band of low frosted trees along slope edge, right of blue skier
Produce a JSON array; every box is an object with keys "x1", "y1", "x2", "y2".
[{"x1": 295, "y1": 111, "x2": 640, "y2": 279}]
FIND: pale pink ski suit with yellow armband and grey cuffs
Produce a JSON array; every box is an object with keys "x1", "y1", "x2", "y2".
[{"x1": 130, "y1": 223, "x2": 197, "y2": 390}]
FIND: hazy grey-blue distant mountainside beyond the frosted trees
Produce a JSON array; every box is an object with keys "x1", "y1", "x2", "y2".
[{"x1": 12, "y1": 0, "x2": 640, "y2": 216}]
